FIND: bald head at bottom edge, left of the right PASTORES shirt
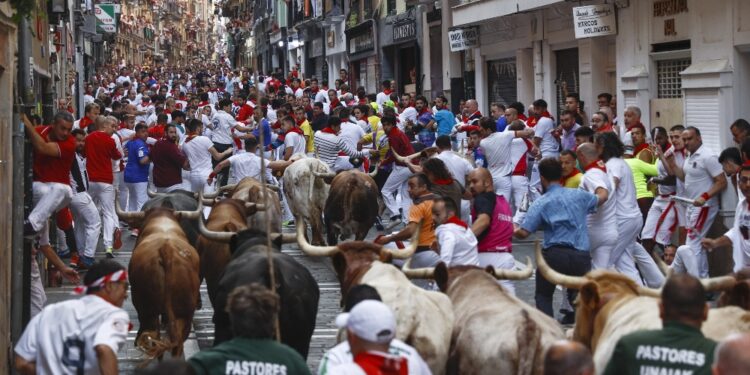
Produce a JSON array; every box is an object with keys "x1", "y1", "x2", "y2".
[{"x1": 544, "y1": 340, "x2": 594, "y2": 375}]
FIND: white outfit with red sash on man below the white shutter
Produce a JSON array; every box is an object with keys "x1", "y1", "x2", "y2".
[{"x1": 678, "y1": 145, "x2": 724, "y2": 278}]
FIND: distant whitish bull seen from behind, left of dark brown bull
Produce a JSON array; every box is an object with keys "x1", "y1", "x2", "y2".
[{"x1": 284, "y1": 158, "x2": 334, "y2": 245}]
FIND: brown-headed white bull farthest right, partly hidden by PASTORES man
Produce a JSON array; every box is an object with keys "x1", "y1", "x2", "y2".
[{"x1": 536, "y1": 248, "x2": 750, "y2": 370}]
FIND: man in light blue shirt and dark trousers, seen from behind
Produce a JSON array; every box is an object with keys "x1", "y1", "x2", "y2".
[{"x1": 514, "y1": 158, "x2": 599, "y2": 316}]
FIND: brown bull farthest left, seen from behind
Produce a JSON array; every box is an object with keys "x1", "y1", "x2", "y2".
[{"x1": 128, "y1": 204, "x2": 202, "y2": 358}]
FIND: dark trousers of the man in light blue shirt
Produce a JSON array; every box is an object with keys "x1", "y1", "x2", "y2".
[{"x1": 534, "y1": 246, "x2": 591, "y2": 318}]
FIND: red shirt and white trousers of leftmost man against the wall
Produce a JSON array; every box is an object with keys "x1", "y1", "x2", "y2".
[{"x1": 28, "y1": 126, "x2": 76, "y2": 246}]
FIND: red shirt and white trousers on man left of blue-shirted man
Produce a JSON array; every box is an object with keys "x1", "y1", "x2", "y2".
[{"x1": 86, "y1": 130, "x2": 122, "y2": 249}]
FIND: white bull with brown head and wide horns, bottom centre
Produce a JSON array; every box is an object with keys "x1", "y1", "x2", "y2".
[{"x1": 296, "y1": 223, "x2": 453, "y2": 375}]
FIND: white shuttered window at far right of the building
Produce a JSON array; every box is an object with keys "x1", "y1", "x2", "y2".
[{"x1": 684, "y1": 89, "x2": 721, "y2": 154}]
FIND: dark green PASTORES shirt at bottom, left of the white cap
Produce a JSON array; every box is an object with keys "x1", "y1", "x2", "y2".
[{"x1": 188, "y1": 337, "x2": 310, "y2": 375}]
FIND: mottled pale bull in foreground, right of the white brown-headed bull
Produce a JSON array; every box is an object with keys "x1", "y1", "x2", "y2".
[{"x1": 403, "y1": 250, "x2": 565, "y2": 375}]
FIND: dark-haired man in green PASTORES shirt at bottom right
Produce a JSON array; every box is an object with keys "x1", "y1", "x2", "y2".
[{"x1": 604, "y1": 274, "x2": 716, "y2": 375}]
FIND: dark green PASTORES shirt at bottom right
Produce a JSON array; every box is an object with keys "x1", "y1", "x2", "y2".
[{"x1": 604, "y1": 321, "x2": 716, "y2": 375}]
